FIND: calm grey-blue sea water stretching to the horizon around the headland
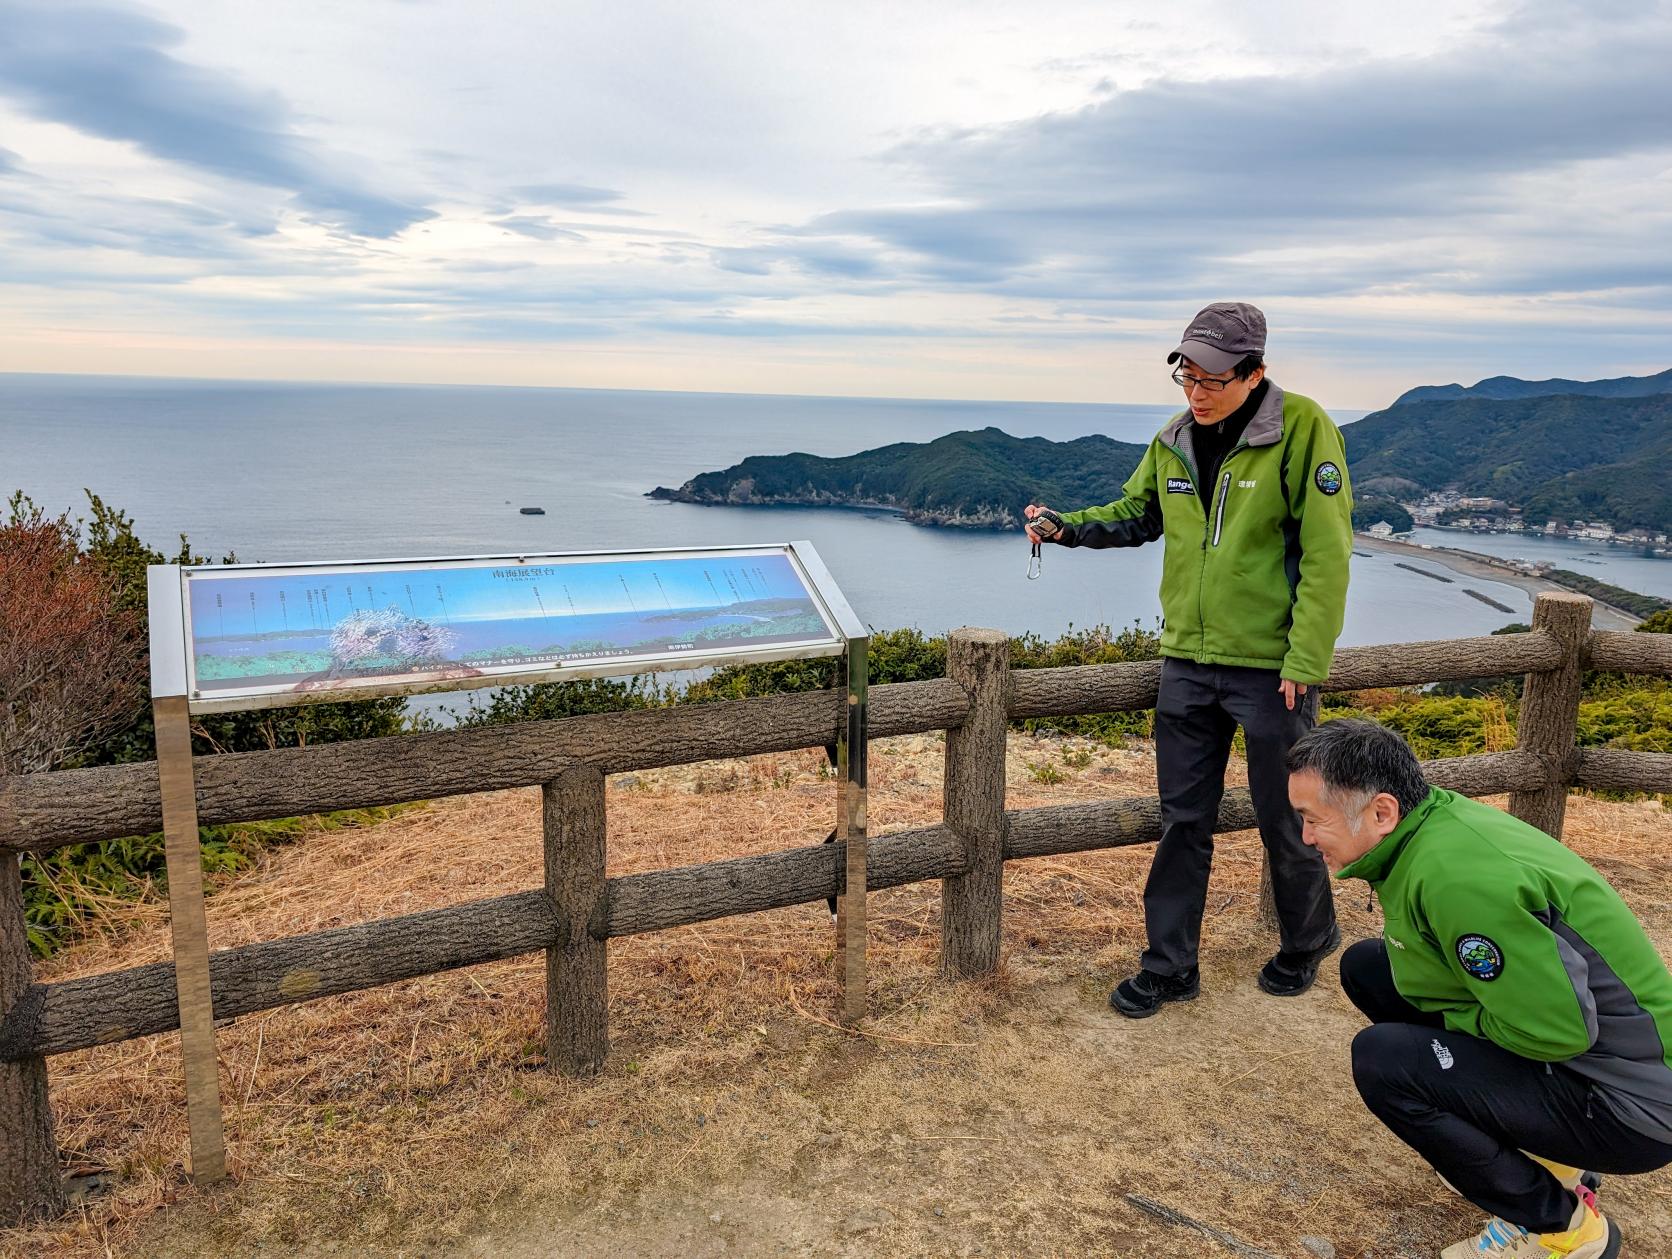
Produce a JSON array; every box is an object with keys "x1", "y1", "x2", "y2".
[{"x1": 0, "y1": 375, "x2": 1672, "y2": 658}]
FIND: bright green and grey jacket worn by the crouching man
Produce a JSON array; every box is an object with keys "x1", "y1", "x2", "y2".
[{"x1": 1338, "y1": 788, "x2": 1672, "y2": 1140}]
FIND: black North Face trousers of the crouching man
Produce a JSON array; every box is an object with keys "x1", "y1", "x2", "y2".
[{"x1": 1341, "y1": 940, "x2": 1672, "y2": 1232}]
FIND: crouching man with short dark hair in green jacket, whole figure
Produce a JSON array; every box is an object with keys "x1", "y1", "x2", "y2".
[{"x1": 1289, "y1": 719, "x2": 1672, "y2": 1259}]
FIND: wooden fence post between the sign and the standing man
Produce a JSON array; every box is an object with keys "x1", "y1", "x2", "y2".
[{"x1": 941, "y1": 629, "x2": 1010, "y2": 980}]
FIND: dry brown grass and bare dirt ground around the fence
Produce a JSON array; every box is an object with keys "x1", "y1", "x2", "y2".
[{"x1": 0, "y1": 736, "x2": 1672, "y2": 1259}]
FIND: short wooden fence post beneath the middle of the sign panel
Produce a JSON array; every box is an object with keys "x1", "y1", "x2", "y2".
[{"x1": 542, "y1": 766, "x2": 610, "y2": 1075}]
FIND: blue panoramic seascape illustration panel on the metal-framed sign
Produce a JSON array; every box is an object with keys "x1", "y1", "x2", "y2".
[{"x1": 186, "y1": 547, "x2": 838, "y2": 697}]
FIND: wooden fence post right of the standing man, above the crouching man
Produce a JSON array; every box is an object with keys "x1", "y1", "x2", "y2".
[{"x1": 1510, "y1": 594, "x2": 1592, "y2": 839}]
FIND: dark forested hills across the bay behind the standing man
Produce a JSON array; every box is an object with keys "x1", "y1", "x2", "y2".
[{"x1": 649, "y1": 370, "x2": 1672, "y2": 530}]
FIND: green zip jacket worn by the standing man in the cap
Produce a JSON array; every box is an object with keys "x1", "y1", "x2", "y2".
[{"x1": 1055, "y1": 385, "x2": 1353, "y2": 682}]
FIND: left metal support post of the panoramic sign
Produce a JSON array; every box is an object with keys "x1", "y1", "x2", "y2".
[{"x1": 147, "y1": 567, "x2": 226, "y2": 1184}]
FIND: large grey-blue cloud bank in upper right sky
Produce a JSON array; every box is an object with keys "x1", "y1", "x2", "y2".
[{"x1": 775, "y1": 3, "x2": 1672, "y2": 307}]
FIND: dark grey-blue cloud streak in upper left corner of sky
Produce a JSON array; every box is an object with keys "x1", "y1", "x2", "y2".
[{"x1": 0, "y1": 0, "x2": 431, "y2": 236}]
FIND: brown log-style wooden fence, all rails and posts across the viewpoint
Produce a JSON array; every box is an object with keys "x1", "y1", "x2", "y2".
[{"x1": 0, "y1": 595, "x2": 1672, "y2": 1224}]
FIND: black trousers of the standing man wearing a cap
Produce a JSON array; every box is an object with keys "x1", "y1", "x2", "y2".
[{"x1": 1142, "y1": 655, "x2": 1336, "y2": 975}]
